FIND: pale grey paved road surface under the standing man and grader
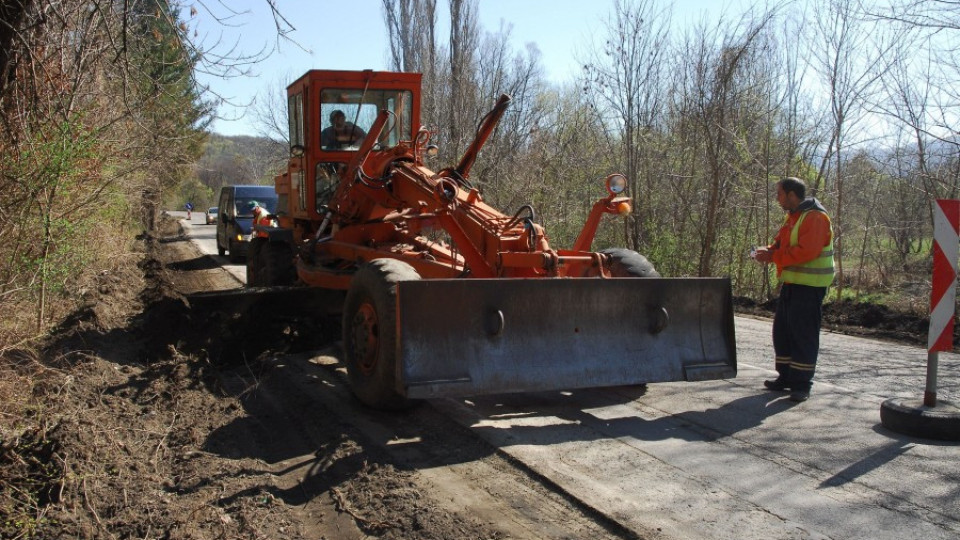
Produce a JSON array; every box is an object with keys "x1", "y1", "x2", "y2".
[{"x1": 174, "y1": 213, "x2": 960, "y2": 540}]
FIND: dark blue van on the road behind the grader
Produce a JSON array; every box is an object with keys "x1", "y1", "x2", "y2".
[{"x1": 217, "y1": 185, "x2": 277, "y2": 263}]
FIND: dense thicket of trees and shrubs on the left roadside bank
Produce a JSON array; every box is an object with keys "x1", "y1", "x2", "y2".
[{"x1": 0, "y1": 0, "x2": 255, "y2": 339}]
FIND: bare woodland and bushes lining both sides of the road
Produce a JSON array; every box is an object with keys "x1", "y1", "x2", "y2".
[{"x1": 0, "y1": 0, "x2": 960, "y2": 354}]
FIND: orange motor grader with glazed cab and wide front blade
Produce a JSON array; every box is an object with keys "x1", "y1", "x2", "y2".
[{"x1": 247, "y1": 70, "x2": 736, "y2": 409}]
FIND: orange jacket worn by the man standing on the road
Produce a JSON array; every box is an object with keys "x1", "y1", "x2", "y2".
[{"x1": 767, "y1": 197, "x2": 833, "y2": 277}]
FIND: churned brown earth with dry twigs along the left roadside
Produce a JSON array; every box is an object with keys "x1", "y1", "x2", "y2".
[{"x1": 0, "y1": 214, "x2": 510, "y2": 539}]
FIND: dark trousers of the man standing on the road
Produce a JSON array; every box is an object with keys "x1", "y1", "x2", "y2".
[{"x1": 773, "y1": 283, "x2": 827, "y2": 392}]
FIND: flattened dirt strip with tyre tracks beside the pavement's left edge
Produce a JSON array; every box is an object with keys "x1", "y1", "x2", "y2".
[{"x1": 209, "y1": 347, "x2": 638, "y2": 539}]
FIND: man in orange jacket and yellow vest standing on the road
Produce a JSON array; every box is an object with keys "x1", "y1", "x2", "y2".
[{"x1": 753, "y1": 177, "x2": 834, "y2": 402}]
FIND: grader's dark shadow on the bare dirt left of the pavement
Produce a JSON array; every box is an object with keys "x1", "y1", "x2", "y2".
[{"x1": 203, "y1": 352, "x2": 495, "y2": 505}]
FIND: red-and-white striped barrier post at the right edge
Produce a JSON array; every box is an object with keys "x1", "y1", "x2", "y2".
[{"x1": 923, "y1": 199, "x2": 960, "y2": 407}]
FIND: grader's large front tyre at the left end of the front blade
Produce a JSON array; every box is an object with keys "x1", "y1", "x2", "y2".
[{"x1": 342, "y1": 259, "x2": 420, "y2": 410}]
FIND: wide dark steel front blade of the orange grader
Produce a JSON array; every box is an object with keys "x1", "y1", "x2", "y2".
[{"x1": 397, "y1": 278, "x2": 737, "y2": 398}]
